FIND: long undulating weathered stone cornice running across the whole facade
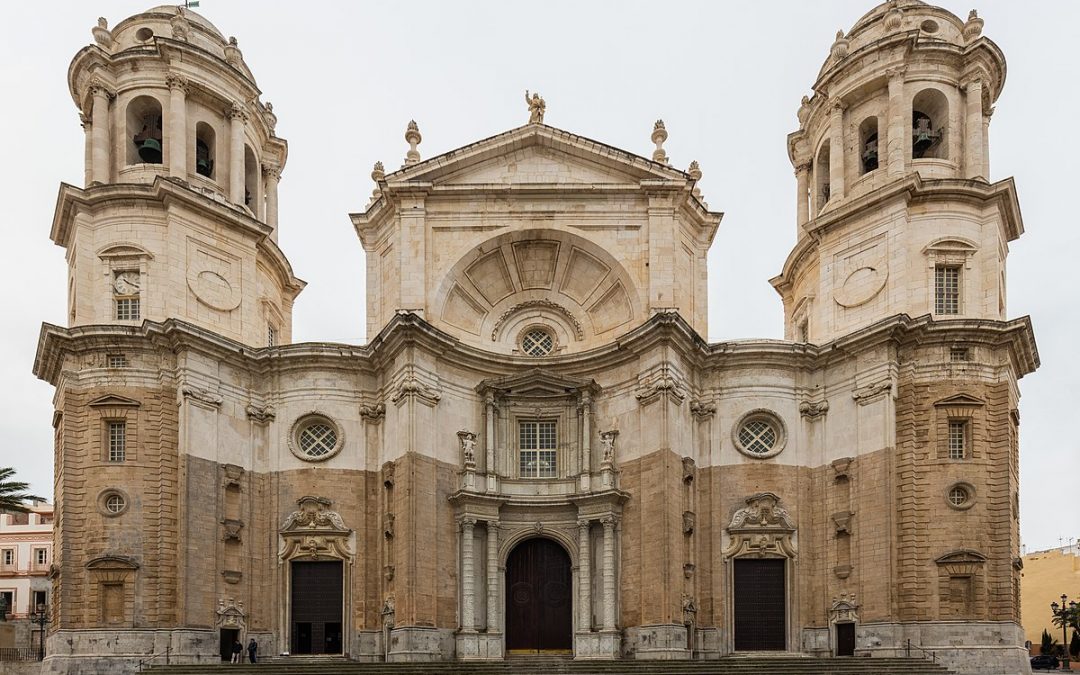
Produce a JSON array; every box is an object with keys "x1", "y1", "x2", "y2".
[{"x1": 33, "y1": 312, "x2": 1039, "y2": 386}]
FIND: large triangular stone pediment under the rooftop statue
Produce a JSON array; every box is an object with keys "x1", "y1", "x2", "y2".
[{"x1": 387, "y1": 124, "x2": 690, "y2": 186}]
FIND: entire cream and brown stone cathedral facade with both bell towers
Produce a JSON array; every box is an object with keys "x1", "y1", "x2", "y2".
[{"x1": 35, "y1": 0, "x2": 1038, "y2": 673}]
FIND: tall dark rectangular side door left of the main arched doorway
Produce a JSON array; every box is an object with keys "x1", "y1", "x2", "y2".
[{"x1": 289, "y1": 561, "x2": 343, "y2": 653}]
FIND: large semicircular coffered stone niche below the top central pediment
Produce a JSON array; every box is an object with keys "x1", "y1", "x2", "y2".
[{"x1": 432, "y1": 229, "x2": 643, "y2": 353}]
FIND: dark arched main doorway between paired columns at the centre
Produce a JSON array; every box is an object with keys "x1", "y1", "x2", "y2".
[{"x1": 507, "y1": 538, "x2": 573, "y2": 654}]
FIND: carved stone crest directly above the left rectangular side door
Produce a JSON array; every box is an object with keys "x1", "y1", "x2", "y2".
[{"x1": 278, "y1": 496, "x2": 353, "y2": 564}]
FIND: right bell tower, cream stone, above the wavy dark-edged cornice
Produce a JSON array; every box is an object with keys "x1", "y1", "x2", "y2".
[{"x1": 772, "y1": 0, "x2": 1024, "y2": 342}]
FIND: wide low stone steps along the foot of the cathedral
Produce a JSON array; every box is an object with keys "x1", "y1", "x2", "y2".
[{"x1": 143, "y1": 654, "x2": 951, "y2": 675}]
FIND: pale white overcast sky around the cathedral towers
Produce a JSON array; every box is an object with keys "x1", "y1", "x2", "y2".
[{"x1": 0, "y1": 0, "x2": 1080, "y2": 551}]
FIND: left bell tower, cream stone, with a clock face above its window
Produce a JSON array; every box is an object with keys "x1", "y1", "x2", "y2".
[{"x1": 51, "y1": 5, "x2": 303, "y2": 347}]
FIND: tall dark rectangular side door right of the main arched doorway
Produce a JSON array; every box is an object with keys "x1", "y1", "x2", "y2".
[{"x1": 734, "y1": 558, "x2": 787, "y2": 651}]
